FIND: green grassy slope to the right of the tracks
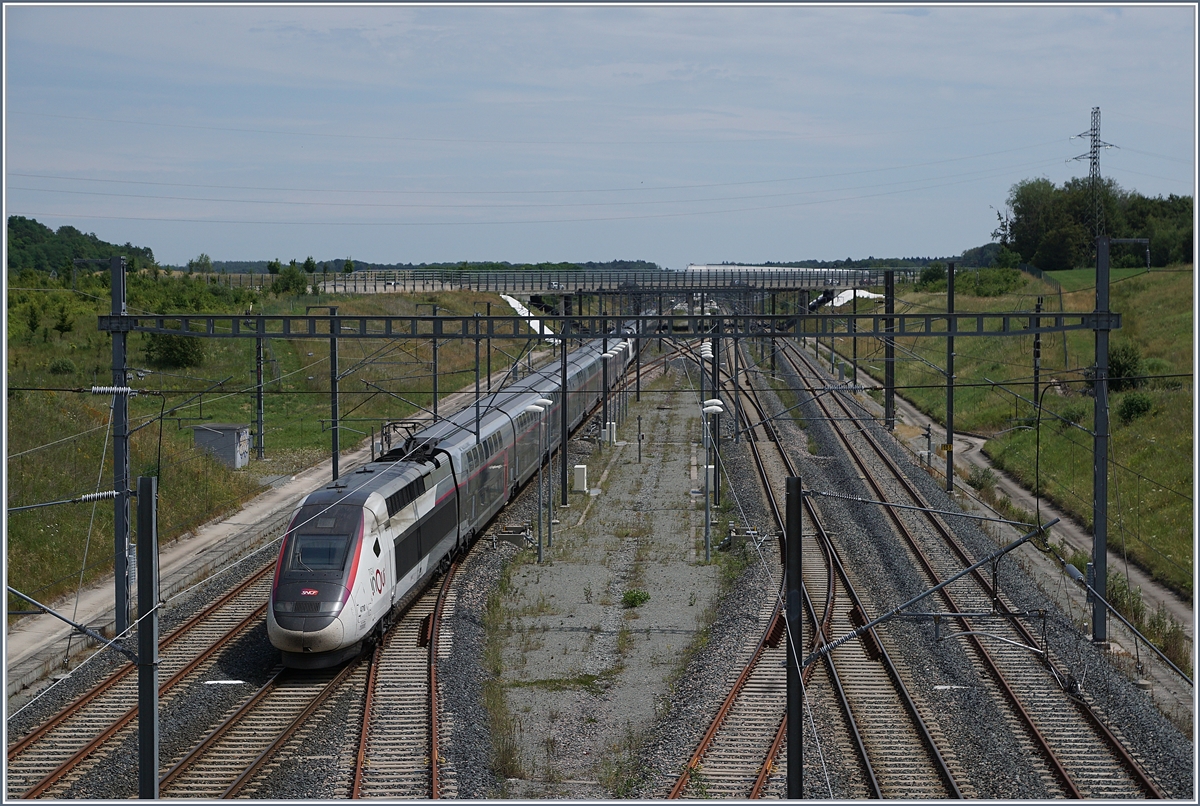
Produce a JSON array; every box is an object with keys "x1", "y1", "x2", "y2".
[{"x1": 838, "y1": 265, "x2": 1194, "y2": 597}]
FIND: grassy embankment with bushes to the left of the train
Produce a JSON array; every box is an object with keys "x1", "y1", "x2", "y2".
[{"x1": 6, "y1": 278, "x2": 511, "y2": 609}]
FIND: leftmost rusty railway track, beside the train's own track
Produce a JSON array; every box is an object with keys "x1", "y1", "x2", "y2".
[{"x1": 7, "y1": 564, "x2": 272, "y2": 798}]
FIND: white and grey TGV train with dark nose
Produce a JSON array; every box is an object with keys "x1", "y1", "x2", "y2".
[{"x1": 266, "y1": 333, "x2": 636, "y2": 668}]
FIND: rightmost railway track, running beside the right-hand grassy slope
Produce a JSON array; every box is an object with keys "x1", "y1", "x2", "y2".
[{"x1": 784, "y1": 344, "x2": 1163, "y2": 798}]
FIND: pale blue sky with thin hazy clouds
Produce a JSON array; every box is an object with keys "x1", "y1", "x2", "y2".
[{"x1": 4, "y1": 4, "x2": 1196, "y2": 269}]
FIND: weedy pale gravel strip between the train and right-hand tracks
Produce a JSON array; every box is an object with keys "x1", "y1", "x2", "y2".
[{"x1": 489, "y1": 367, "x2": 725, "y2": 798}]
